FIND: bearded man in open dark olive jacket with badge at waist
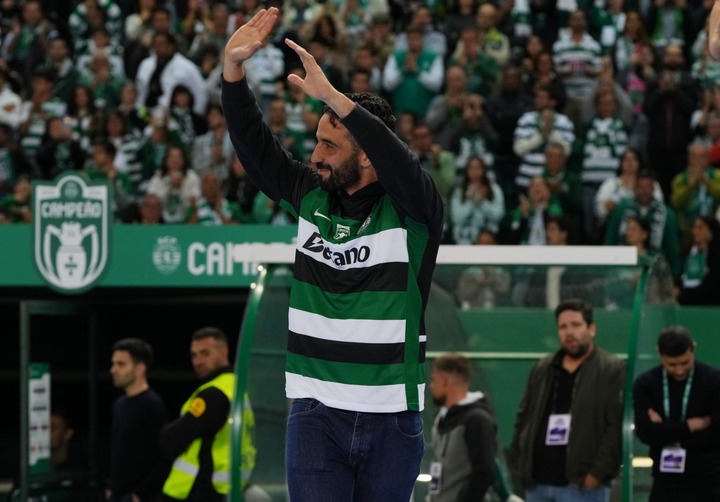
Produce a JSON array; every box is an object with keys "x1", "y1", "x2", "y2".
[{"x1": 510, "y1": 299, "x2": 625, "y2": 502}]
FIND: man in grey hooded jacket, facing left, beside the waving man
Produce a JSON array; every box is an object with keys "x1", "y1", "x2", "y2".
[{"x1": 427, "y1": 354, "x2": 497, "y2": 502}]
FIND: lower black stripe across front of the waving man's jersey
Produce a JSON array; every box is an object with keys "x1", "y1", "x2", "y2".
[{"x1": 288, "y1": 331, "x2": 408, "y2": 364}]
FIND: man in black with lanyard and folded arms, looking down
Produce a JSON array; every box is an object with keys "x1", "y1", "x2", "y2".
[{"x1": 633, "y1": 326, "x2": 720, "y2": 502}]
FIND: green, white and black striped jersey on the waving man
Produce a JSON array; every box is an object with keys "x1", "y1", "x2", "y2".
[{"x1": 286, "y1": 188, "x2": 427, "y2": 412}]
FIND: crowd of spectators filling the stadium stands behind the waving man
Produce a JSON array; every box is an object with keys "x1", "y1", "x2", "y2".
[{"x1": 0, "y1": 0, "x2": 720, "y2": 303}]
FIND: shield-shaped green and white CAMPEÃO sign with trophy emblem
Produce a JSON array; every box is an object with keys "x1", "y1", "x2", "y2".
[{"x1": 32, "y1": 174, "x2": 110, "y2": 293}]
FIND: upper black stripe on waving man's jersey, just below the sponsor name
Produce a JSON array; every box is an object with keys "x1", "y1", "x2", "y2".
[{"x1": 295, "y1": 251, "x2": 408, "y2": 294}]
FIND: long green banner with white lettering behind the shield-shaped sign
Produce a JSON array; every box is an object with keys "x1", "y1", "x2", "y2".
[{"x1": 0, "y1": 224, "x2": 297, "y2": 293}]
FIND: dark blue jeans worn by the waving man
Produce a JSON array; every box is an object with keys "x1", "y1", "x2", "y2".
[{"x1": 285, "y1": 399, "x2": 425, "y2": 502}]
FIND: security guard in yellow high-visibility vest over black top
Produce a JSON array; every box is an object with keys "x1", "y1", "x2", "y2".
[{"x1": 160, "y1": 327, "x2": 264, "y2": 502}]
